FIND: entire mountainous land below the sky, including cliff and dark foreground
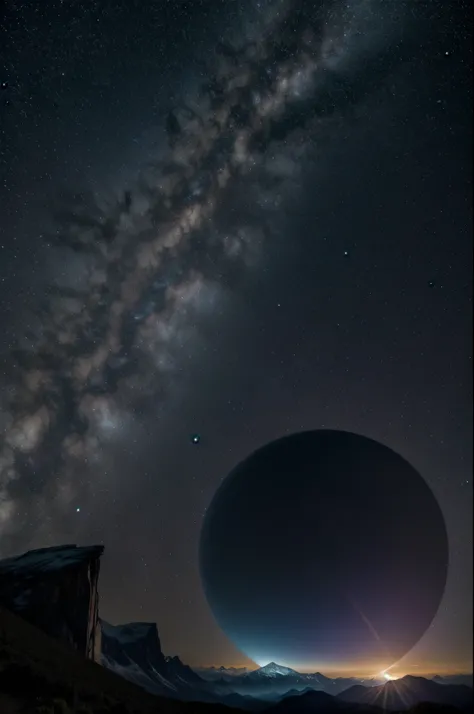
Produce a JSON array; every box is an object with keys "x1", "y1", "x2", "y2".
[{"x1": 0, "y1": 545, "x2": 472, "y2": 714}]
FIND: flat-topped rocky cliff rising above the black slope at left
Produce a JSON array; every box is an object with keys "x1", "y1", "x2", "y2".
[{"x1": 0, "y1": 545, "x2": 104, "y2": 661}]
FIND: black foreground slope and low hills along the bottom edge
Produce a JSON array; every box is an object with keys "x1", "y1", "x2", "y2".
[{"x1": 0, "y1": 592, "x2": 472, "y2": 714}]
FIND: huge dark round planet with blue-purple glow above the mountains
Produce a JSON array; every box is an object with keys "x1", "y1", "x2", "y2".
[{"x1": 199, "y1": 430, "x2": 448, "y2": 673}]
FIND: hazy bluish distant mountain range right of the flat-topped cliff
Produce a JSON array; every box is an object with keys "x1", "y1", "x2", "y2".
[{"x1": 98, "y1": 623, "x2": 472, "y2": 714}]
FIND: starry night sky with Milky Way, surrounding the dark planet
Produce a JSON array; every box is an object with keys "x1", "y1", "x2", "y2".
[{"x1": 0, "y1": 0, "x2": 472, "y2": 673}]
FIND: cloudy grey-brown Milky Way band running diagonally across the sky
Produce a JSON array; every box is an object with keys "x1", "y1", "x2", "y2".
[{"x1": 0, "y1": 1, "x2": 408, "y2": 537}]
